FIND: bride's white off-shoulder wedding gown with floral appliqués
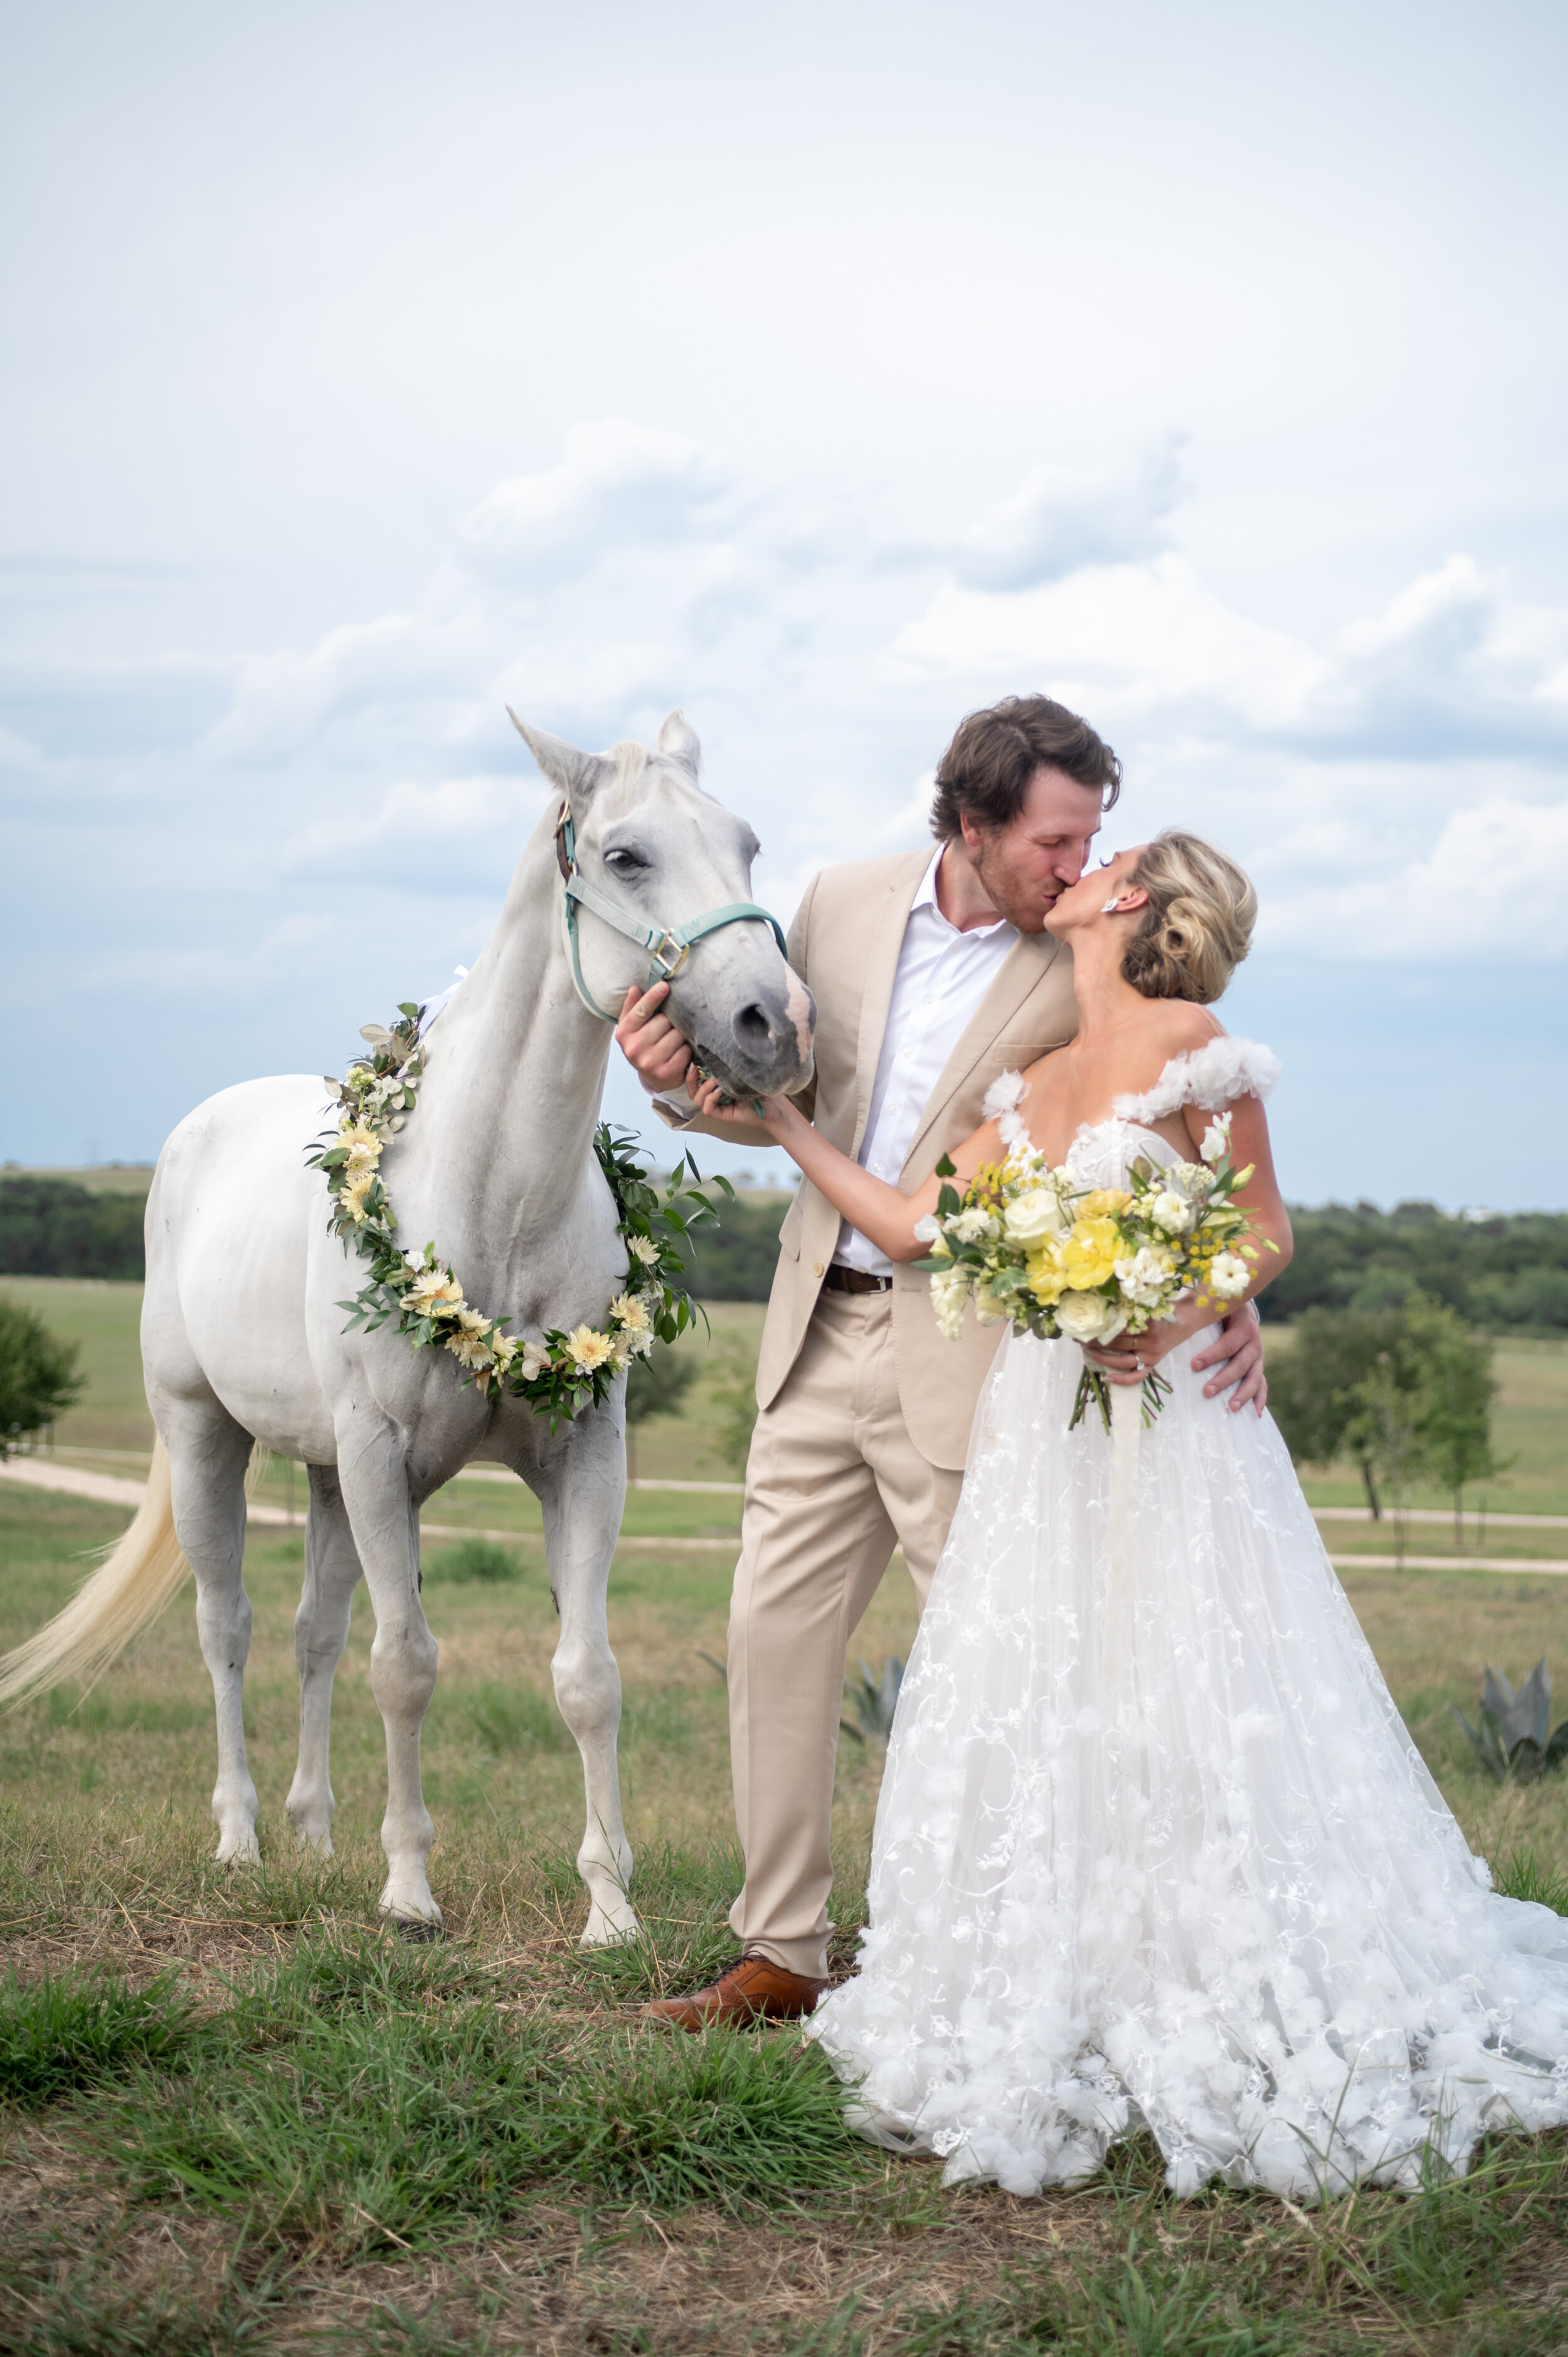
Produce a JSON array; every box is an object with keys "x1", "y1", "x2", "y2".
[{"x1": 808, "y1": 1037, "x2": 1568, "y2": 2199}]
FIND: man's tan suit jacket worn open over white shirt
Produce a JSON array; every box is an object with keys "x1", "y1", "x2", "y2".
[{"x1": 655, "y1": 849, "x2": 1078, "y2": 1471}]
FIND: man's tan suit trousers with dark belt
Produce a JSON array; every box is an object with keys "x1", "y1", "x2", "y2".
[{"x1": 729, "y1": 1294, "x2": 965, "y2": 1978}]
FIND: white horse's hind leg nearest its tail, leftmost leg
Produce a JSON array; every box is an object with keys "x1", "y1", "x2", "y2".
[{"x1": 158, "y1": 1397, "x2": 260, "y2": 1865}]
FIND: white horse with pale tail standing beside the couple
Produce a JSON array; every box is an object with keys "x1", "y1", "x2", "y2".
[{"x1": 0, "y1": 712, "x2": 813, "y2": 1942}]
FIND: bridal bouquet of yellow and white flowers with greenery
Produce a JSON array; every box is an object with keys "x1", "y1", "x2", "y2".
[{"x1": 915, "y1": 1113, "x2": 1257, "y2": 1428}]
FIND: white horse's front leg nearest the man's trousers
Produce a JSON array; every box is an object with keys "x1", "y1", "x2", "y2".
[{"x1": 531, "y1": 1390, "x2": 637, "y2": 1947}]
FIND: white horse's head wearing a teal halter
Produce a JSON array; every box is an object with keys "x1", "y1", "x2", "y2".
[{"x1": 512, "y1": 712, "x2": 816, "y2": 1096}]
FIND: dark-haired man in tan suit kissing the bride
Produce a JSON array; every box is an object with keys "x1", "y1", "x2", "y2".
[{"x1": 615, "y1": 696, "x2": 1264, "y2": 2030}]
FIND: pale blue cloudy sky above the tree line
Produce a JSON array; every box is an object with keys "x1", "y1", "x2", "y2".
[{"x1": 0, "y1": 0, "x2": 1568, "y2": 1207}]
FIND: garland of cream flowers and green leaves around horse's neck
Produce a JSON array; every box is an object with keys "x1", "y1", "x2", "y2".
[{"x1": 307, "y1": 1002, "x2": 736, "y2": 1431}]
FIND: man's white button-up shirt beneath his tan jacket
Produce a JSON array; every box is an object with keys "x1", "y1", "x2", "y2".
[{"x1": 832, "y1": 844, "x2": 1019, "y2": 1278}]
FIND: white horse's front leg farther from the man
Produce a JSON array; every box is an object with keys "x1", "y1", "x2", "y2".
[{"x1": 337, "y1": 1400, "x2": 441, "y2": 1924}]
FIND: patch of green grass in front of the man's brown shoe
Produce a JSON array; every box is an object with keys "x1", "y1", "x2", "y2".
[{"x1": 110, "y1": 1949, "x2": 872, "y2": 2258}]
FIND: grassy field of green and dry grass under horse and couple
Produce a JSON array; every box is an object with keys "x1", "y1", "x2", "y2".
[{"x1": 0, "y1": 1284, "x2": 1568, "y2": 2357}]
